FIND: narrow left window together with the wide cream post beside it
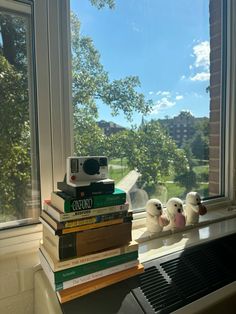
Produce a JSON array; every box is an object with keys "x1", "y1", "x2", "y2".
[{"x1": 0, "y1": 0, "x2": 71, "y2": 229}]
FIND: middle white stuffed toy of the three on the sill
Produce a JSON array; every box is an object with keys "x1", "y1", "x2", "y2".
[{"x1": 166, "y1": 197, "x2": 186, "y2": 229}]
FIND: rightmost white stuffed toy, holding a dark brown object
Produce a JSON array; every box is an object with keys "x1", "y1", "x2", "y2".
[{"x1": 184, "y1": 192, "x2": 207, "y2": 225}]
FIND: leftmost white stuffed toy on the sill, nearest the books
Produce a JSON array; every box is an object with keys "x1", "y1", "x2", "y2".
[{"x1": 146, "y1": 198, "x2": 169, "y2": 233}]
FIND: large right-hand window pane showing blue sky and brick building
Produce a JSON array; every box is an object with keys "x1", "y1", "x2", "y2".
[{"x1": 71, "y1": 0, "x2": 223, "y2": 210}]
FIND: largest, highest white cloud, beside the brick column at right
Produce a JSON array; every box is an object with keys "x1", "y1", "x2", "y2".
[{"x1": 193, "y1": 41, "x2": 210, "y2": 69}]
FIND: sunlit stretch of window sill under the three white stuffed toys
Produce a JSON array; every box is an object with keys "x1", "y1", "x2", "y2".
[{"x1": 135, "y1": 207, "x2": 236, "y2": 263}]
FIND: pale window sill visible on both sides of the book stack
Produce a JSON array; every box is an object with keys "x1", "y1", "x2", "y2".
[{"x1": 0, "y1": 207, "x2": 236, "y2": 261}]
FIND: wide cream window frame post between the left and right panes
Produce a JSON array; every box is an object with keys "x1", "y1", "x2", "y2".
[{"x1": 0, "y1": 0, "x2": 73, "y2": 232}]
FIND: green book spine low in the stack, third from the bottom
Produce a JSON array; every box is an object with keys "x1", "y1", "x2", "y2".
[{"x1": 54, "y1": 251, "x2": 138, "y2": 284}]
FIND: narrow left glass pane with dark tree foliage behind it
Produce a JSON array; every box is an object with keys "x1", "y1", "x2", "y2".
[{"x1": 0, "y1": 10, "x2": 40, "y2": 228}]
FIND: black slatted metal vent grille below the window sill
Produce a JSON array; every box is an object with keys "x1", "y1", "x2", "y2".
[{"x1": 133, "y1": 234, "x2": 236, "y2": 313}]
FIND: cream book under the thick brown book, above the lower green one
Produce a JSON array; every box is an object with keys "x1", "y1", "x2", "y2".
[{"x1": 39, "y1": 241, "x2": 138, "y2": 272}]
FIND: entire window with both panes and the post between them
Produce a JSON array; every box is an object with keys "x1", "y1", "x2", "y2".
[{"x1": 0, "y1": 0, "x2": 236, "y2": 228}]
